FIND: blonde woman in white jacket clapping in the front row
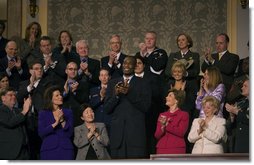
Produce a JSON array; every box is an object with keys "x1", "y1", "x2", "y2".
[{"x1": 188, "y1": 96, "x2": 227, "y2": 154}]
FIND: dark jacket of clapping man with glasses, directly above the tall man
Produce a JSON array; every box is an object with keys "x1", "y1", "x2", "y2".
[{"x1": 101, "y1": 53, "x2": 127, "y2": 79}]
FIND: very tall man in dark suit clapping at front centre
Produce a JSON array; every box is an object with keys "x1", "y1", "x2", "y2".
[{"x1": 104, "y1": 56, "x2": 151, "y2": 159}]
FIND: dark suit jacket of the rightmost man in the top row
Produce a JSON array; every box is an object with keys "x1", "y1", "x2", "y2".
[{"x1": 201, "y1": 51, "x2": 239, "y2": 93}]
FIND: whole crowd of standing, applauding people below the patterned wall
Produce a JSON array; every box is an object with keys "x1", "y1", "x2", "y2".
[{"x1": 0, "y1": 22, "x2": 249, "y2": 160}]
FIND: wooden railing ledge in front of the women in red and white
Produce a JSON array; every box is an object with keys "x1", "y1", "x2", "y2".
[{"x1": 150, "y1": 153, "x2": 250, "y2": 161}]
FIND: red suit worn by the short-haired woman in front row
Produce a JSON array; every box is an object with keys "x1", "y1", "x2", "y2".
[{"x1": 154, "y1": 109, "x2": 189, "y2": 154}]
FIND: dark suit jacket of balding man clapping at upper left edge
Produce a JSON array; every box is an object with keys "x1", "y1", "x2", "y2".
[{"x1": 0, "y1": 56, "x2": 30, "y2": 90}]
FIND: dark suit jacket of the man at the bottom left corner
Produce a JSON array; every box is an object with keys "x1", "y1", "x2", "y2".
[{"x1": 0, "y1": 105, "x2": 27, "y2": 160}]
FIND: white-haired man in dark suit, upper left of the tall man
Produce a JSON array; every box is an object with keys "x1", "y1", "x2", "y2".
[{"x1": 74, "y1": 40, "x2": 100, "y2": 88}]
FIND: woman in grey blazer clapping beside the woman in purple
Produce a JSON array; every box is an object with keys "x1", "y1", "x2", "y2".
[{"x1": 74, "y1": 104, "x2": 110, "y2": 160}]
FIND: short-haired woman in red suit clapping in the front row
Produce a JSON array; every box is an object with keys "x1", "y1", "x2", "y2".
[{"x1": 155, "y1": 88, "x2": 189, "y2": 154}]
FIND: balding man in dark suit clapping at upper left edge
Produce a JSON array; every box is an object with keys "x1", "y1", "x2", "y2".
[{"x1": 0, "y1": 41, "x2": 29, "y2": 90}]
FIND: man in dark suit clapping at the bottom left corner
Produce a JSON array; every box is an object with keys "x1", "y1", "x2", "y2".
[{"x1": 0, "y1": 88, "x2": 31, "y2": 160}]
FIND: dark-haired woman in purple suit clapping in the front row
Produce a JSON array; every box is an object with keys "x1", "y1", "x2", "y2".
[{"x1": 38, "y1": 86, "x2": 74, "y2": 160}]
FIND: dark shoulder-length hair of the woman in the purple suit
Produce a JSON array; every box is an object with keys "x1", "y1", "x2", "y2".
[{"x1": 44, "y1": 85, "x2": 62, "y2": 110}]
